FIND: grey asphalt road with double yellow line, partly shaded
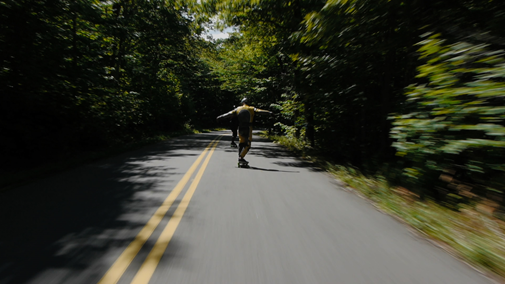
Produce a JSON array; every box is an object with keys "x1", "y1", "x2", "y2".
[{"x1": 0, "y1": 131, "x2": 491, "y2": 284}]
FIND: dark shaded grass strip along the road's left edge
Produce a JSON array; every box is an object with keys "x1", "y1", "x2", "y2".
[{"x1": 0, "y1": 127, "x2": 223, "y2": 192}]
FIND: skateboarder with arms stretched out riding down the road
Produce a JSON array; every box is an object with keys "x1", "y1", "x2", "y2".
[{"x1": 217, "y1": 98, "x2": 272, "y2": 167}]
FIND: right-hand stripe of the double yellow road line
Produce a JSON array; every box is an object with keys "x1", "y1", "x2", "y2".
[{"x1": 131, "y1": 138, "x2": 217, "y2": 284}]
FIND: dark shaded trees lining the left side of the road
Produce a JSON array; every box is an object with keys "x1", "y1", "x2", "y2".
[{"x1": 0, "y1": 0, "x2": 221, "y2": 169}]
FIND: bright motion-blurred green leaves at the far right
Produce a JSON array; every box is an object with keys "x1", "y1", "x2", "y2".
[{"x1": 391, "y1": 32, "x2": 505, "y2": 191}]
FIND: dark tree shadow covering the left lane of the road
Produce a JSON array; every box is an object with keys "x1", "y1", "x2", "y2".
[{"x1": 0, "y1": 132, "x2": 222, "y2": 283}]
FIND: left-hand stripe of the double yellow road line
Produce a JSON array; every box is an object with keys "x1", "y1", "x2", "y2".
[{"x1": 98, "y1": 138, "x2": 220, "y2": 284}]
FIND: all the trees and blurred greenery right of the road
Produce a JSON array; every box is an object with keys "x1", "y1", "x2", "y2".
[{"x1": 199, "y1": 0, "x2": 505, "y2": 208}]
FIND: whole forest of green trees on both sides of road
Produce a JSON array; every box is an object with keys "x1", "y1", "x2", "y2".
[{"x1": 0, "y1": 0, "x2": 505, "y2": 204}]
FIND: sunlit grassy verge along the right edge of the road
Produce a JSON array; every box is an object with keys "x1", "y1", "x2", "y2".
[{"x1": 263, "y1": 133, "x2": 505, "y2": 282}]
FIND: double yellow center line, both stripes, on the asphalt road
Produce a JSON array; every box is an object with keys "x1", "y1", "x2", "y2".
[{"x1": 98, "y1": 136, "x2": 221, "y2": 284}]
